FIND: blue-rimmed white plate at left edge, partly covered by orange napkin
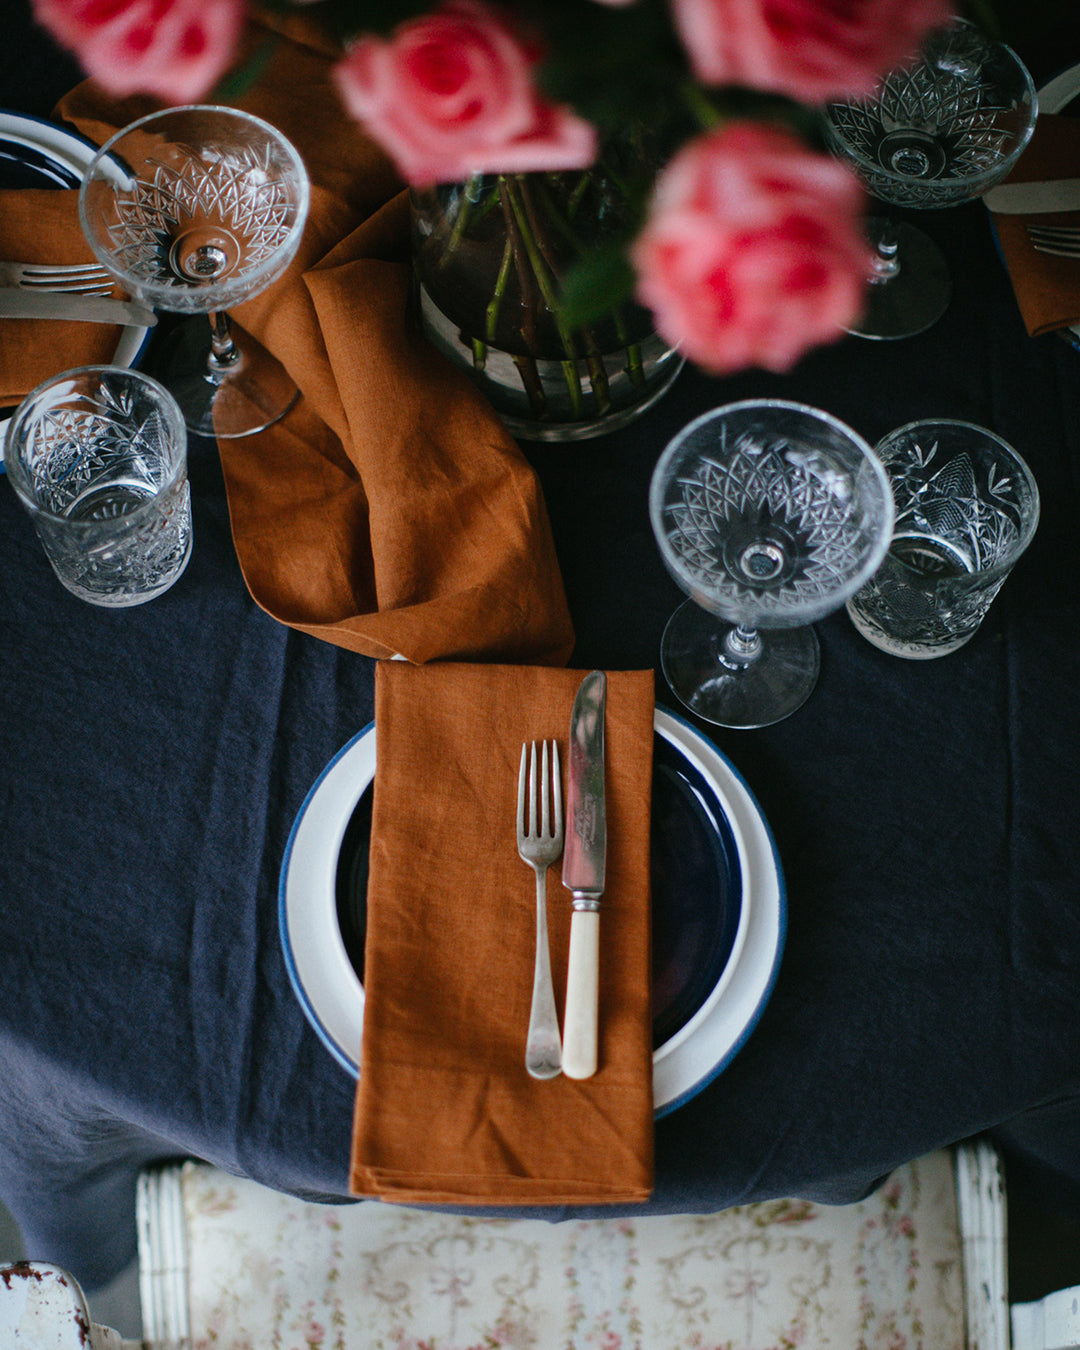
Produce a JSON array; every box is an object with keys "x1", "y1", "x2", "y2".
[{"x1": 0, "y1": 108, "x2": 150, "y2": 474}]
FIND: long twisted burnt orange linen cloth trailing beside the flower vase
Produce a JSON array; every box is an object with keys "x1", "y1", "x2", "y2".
[{"x1": 52, "y1": 23, "x2": 574, "y2": 664}]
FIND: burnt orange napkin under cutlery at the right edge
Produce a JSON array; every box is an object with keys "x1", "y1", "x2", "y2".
[{"x1": 992, "y1": 113, "x2": 1080, "y2": 338}]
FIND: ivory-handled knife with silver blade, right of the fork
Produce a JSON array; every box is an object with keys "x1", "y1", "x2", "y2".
[{"x1": 563, "y1": 671, "x2": 608, "y2": 1079}]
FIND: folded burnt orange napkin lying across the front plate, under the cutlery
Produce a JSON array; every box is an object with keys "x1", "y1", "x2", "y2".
[{"x1": 351, "y1": 662, "x2": 653, "y2": 1204}]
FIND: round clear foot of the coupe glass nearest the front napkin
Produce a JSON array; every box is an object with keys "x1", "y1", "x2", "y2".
[{"x1": 660, "y1": 601, "x2": 821, "y2": 730}]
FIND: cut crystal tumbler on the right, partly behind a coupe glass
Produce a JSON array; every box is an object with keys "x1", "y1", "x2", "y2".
[{"x1": 848, "y1": 420, "x2": 1040, "y2": 660}]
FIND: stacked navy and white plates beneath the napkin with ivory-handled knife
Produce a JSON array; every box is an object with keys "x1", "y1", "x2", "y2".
[{"x1": 278, "y1": 709, "x2": 786, "y2": 1116}]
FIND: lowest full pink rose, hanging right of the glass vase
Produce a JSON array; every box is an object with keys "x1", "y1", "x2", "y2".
[{"x1": 632, "y1": 122, "x2": 871, "y2": 374}]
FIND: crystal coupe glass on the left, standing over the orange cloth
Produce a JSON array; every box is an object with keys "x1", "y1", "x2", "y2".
[{"x1": 78, "y1": 104, "x2": 309, "y2": 437}]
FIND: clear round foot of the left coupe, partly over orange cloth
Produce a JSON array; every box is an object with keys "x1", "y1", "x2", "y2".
[{"x1": 153, "y1": 315, "x2": 300, "y2": 440}]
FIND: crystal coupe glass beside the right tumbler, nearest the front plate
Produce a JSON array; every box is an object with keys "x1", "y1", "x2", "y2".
[{"x1": 649, "y1": 400, "x2": 894, "y2": 728}]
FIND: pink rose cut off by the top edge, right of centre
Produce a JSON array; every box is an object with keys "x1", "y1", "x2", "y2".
[{"x1": 671, "y1": 0, "x2": 953, "y2": 103}]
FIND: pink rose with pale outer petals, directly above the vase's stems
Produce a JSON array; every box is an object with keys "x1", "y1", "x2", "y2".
[{"x1": 336, "y1": 0, "x2": 595, "y2": 185}]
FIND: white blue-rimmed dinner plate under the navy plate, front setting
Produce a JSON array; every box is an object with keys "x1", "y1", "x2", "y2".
[{"x1": 278, "y1": 709, "x2": 786, "y2": 1116}]
